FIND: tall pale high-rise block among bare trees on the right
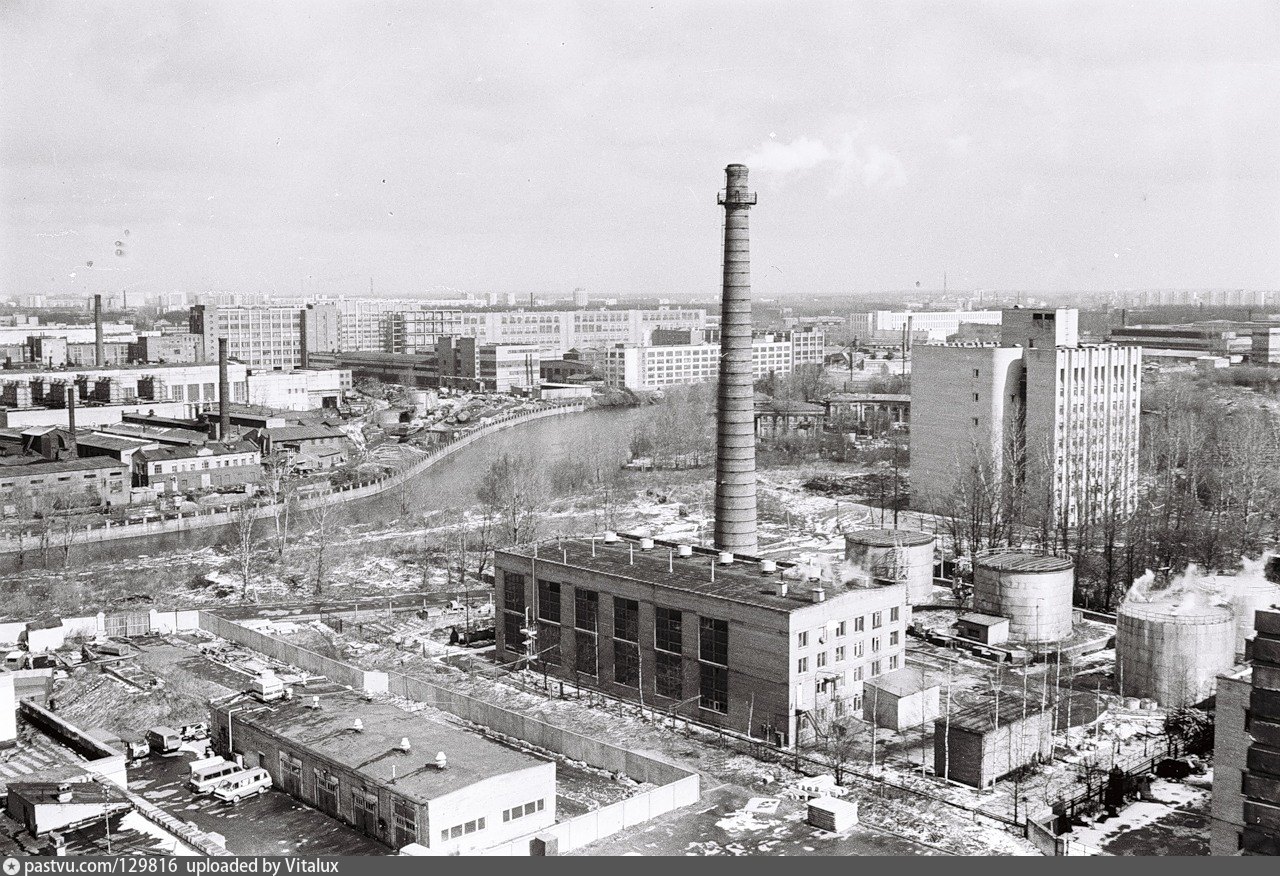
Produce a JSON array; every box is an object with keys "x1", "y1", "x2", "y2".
[{"x1": 911, "y1": 309, "x2": 1142, "y2": 526}]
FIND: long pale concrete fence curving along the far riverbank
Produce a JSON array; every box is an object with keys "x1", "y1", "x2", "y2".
[{"x1": 0, "y1": 402, "x2": 586, "y2": 555}]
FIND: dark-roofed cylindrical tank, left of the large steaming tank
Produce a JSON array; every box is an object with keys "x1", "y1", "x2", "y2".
[{"x1": 973, "y1": 551, "x2": 1075, "y2": 644}]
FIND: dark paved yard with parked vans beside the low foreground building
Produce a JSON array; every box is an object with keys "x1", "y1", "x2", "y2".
[{"x1": 129, "y1": 752, "x2": 393, "y2": 856}]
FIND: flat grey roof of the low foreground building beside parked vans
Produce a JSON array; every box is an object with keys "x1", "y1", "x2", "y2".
[{"x1": 220, "y1": 692, "x2": 547, "y2": 803}]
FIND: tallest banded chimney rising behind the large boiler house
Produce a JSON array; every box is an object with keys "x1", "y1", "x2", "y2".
[{"x1": 716, "y1": 164, "x2": 756, "y2": 553}]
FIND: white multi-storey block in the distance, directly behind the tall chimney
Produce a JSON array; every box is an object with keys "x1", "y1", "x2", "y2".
[{"x1": 602, "y1": 334, "x2": 792, "y2": 391}]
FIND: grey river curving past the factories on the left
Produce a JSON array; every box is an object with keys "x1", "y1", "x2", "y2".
[{"x1": 0, "y1": 407, "x2": 649, "y2": 572}]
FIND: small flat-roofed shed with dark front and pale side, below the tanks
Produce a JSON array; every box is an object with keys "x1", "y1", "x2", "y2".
[{"x1": 933, "y1": 697, "x2": 1053, "y2": 788}]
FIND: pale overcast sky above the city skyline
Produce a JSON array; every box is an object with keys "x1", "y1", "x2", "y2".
[{"x1": 0, "y1": 0, "x2": 1280, "y2": 296}]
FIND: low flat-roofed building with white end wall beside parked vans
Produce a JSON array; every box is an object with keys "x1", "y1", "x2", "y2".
[{"x1": 210, "y1": 693, "x2": 556, "y2": 854}]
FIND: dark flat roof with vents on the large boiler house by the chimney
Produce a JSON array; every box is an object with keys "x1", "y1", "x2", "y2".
[{"x1": 503, "y1": 535, "x2": 901, "y2": 612}]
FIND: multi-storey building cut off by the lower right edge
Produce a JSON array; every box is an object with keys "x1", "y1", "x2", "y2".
[{"x1": 1210, "y1": 610, "x2": 1280, "y2": 856}]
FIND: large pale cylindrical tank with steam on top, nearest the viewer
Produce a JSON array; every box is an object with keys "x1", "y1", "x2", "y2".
[{"x1": 1116, "y1": 602, "x2": 1236, "y2": 708}]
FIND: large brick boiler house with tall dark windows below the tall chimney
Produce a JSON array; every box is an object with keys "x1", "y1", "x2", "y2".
[{"x1": 494, "y1": 533, "x2": 911, "y2": 744}]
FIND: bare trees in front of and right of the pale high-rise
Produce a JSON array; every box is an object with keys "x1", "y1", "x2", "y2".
[{"x1": 938, "y1": 377, "x2": 1280, "y2": 611}]
